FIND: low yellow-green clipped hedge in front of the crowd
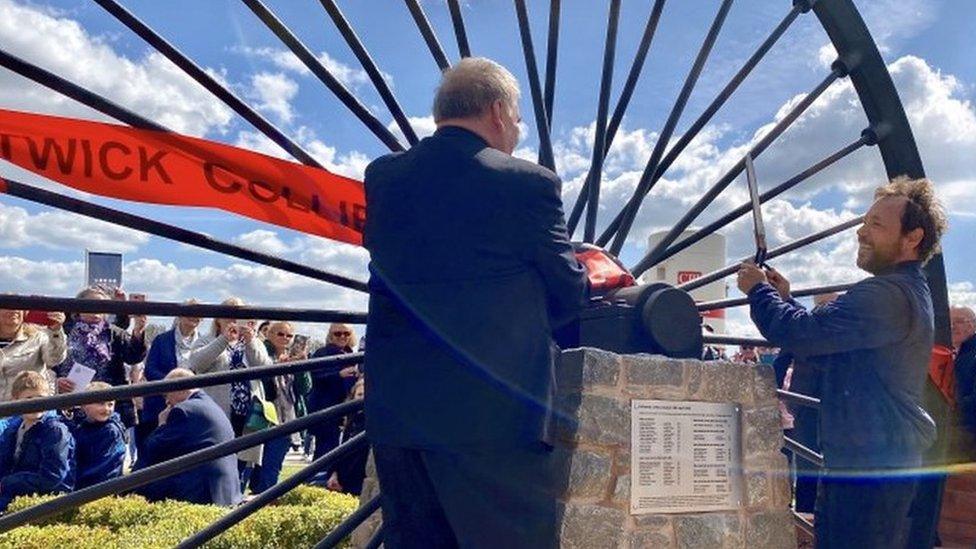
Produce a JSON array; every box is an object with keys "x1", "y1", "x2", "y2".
[{"x1": 0, "y1": 486, "x2": 358, "y2": 549}]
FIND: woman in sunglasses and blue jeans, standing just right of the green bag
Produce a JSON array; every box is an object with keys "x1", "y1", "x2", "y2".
[{"x1": 251, "y1": 322, "x2": 311, "y2": 494}]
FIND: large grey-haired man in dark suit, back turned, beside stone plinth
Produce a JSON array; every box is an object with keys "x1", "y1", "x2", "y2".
[{"x1": 364, "y1": 58, "x2": 587, "y2": 548}]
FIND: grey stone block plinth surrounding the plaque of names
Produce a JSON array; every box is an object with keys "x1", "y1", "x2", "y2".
[{"x1": 352, "y1": 348, "x2": 796, "y2": 549}]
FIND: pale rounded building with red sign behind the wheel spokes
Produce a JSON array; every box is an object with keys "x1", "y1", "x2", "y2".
[{"x1": 639, "y1": 229, "x2": 728, "y2": 334}]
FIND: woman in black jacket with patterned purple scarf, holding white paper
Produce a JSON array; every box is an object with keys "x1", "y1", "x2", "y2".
[{"x1": 55, "y1": 287, "x2": 146, "y2": 428}]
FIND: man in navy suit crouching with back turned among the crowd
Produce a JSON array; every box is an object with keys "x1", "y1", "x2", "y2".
[{"x1": 134, "y1": 368, "x2": 241, "y2": 507}]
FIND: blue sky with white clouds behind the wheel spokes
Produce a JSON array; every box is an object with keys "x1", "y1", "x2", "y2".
[{"x1": 0, "y1": 0, "x2": 976, "y2": 331}]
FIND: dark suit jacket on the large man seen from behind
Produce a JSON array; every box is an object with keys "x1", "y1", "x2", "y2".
[{"x1": 364, "y1": 127, "x2": 586, "y2": 448}]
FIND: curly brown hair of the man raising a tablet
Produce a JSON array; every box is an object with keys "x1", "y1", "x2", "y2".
[{"x1": 874, "y1": 175, "x2": 949, "y2": 263}]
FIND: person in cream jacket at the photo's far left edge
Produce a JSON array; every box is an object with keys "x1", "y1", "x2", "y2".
[{"x1": 0, "y1": 309, "x2": 67, "y2": 402}]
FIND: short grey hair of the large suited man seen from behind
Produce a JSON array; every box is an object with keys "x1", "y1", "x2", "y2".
[{"x1": 433, "y1": 57, "x2": 519, "y2": 122}]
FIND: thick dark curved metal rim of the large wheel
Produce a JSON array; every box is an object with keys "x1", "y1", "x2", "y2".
[{"x1": 813, "y1": 0, "x2": 951, "y2": 345}]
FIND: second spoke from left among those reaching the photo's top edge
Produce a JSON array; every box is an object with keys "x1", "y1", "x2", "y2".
[{"x1": 241, "y1": 0, "x2": 403, "y2": 151}]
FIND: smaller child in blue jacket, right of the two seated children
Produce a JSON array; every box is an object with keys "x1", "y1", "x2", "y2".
[{"x1": 68, "y1": 381, "x2": 126, "y2": 490}]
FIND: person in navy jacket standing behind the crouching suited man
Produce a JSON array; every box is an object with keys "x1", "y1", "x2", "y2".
[{"x1": 135, "y1": 299, "x2": 203, "y2": 448}]
